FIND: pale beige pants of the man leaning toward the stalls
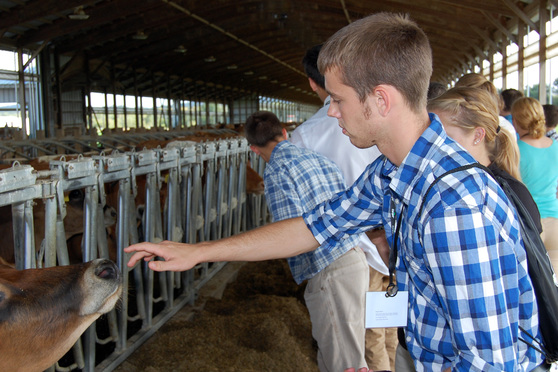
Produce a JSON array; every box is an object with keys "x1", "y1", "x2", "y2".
[{"x1": 304, "y1": 247, "x2": 368, "y2": 372}]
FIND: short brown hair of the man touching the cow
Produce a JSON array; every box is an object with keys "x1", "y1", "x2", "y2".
[{"x1": 318, "y1": 13, "x2": 432, "y2": 113}]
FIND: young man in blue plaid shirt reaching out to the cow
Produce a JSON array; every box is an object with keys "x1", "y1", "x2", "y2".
[{"x1": 126, "y1": 13, "x2": 542, "y2": 372}]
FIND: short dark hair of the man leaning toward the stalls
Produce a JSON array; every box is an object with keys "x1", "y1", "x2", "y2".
[{"x1": 244, "y1": 111, "x2": 283, "y2": 147}]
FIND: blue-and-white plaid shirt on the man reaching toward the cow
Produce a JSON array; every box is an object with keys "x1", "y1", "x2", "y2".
[{"x1": 303, "y1": 115, "x2": 542, "y2": 372}]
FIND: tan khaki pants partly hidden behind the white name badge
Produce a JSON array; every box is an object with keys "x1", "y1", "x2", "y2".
[{"x1": 366, "y1": 267, "x2": 399, "y2": 371}]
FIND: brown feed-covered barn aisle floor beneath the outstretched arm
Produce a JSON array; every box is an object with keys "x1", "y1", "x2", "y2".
[{"x1": 115, "y1": 260, "x2": 318, "y2": 372}]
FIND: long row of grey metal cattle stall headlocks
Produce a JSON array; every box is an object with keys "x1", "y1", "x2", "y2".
[{"x1": 0, "y1": 127, "x2": 267, "y2": 371}]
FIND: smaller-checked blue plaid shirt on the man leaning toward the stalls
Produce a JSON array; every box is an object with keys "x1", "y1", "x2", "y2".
[{"x1": 264, "y1": 141, "x2": 359, "y2": 284}]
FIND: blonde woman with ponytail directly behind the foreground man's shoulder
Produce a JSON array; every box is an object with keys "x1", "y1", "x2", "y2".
[{"x1": 428, "y1": 87, "x2": 542, "y2": 232}]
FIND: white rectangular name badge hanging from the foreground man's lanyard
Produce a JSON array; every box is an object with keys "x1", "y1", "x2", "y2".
[{"x1": 364, "y1": 291, "x2": 409, "y2": 328}]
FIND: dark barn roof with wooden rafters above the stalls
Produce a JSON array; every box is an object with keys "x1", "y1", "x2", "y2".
[{"x1": 0, "y1": 0, "x2": 548, "y2": 103}]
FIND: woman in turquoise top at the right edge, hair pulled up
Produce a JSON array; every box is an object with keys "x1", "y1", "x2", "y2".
[{"x1": 511, "y1": 97, "x2": 558, "y2": 267}]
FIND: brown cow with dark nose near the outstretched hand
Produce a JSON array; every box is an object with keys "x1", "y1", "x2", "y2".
[{"x1": 0, "y1": 259, "x2": 122, "y2": 372}]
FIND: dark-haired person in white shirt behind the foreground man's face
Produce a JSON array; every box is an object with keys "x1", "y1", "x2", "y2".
[{"x1": 290, "y1": 45, "x2": 398, "y2": 371}]
